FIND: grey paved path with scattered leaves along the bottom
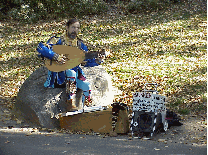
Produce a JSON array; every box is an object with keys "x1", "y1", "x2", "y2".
[{"x1": 0, "y1": 128, "x2": 207, "y2": 155}]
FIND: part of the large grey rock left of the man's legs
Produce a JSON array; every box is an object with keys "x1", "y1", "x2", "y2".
[{"x1": 15, "y1": 67, "x2": 66, "y2": 128}]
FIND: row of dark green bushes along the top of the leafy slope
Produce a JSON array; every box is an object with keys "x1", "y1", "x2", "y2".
[{"x1": 0, "y1": 0, "x2": 182, "y2": 22}]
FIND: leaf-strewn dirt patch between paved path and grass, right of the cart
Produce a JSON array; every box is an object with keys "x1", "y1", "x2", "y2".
[{"x1": 154, "y1": 114, "x2": 207, "y2": 146}]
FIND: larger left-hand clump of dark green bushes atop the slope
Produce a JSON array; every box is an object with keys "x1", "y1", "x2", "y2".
[{"x1": 0, "y1": 0, "x2": 108, "y2": 22}]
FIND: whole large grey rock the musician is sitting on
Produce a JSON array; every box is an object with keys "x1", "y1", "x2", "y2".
[{"x1": 15, "y1": 66, "x2": 114, "y2": 128}]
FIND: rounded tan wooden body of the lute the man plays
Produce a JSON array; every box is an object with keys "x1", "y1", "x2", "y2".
[{"x1": 45, "y1": 45, "x2": 85, "y2": 72}]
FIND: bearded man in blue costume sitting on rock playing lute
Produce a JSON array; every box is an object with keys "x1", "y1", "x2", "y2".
[{"x1": 37, "y1": 18, "x2": 90, "y2": 111}]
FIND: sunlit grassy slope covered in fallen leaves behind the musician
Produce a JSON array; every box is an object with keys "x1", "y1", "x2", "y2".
[{"x1": 0, "y1": 1, "x2": 207, "y2": 117}]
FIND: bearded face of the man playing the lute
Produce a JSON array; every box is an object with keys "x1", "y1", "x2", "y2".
[{"x1": 67, "y1": 22, "x2": 80, "y2": 39}]
